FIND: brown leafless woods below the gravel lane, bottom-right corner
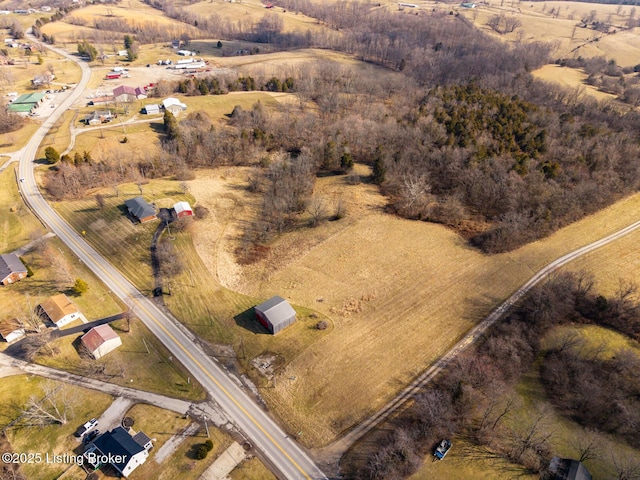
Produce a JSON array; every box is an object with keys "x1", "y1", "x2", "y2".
[{"x1": 345, "y1": 273, "x2": 640, "y2": 480}]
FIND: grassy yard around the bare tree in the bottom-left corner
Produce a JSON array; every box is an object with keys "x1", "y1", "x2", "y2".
[{"x1": 0, "y1": 375, "x2": 112, "y2": 480}]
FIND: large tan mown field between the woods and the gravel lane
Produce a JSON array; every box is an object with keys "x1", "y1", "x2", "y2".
[{"x1": 189, "y1": 162, "x2": 640, "y2": 445}]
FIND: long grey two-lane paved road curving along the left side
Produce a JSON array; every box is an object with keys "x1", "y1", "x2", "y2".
[{"x1": 19, "y1": 36, "x2": 327, "y2": 480}]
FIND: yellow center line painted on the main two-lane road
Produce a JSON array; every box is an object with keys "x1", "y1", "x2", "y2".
[{"x1": 37, "y1": 207, "x2": 311, "y2": 480}]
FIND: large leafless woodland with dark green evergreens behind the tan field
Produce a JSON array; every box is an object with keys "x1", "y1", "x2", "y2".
[{"x1": 46, "y1": 1, "x2": 640, "y2": 255}]
